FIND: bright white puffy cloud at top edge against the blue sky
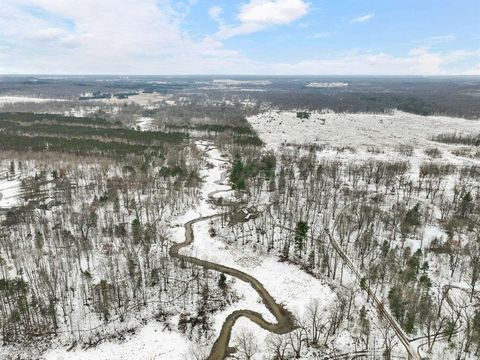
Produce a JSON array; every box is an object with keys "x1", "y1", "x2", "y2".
[{"x1": 214, "y1": 0, "x2": 309, "y2": 40}]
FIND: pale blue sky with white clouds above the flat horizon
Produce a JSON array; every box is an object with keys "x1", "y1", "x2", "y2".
[{"x1": 0, "y1": 0, "x2": 480, "y2": 75}]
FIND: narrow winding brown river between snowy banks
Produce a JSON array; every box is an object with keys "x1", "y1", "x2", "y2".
[{"x1": 169, "y1": 144, "x2": 296, "y2": 360}]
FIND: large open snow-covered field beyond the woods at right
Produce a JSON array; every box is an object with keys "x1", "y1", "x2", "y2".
[{"x1": 247, "y1": 110, "x2": 480, "y2": 148}]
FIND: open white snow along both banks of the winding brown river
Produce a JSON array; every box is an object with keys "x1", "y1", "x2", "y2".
[{"x1": 165, "y1": 143, "x2": 336, "y2": 353}]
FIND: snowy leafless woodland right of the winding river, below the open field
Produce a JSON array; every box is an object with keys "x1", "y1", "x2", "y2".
[{"x1": 223, "y1": 143, "x2": 480, "y2": 355}]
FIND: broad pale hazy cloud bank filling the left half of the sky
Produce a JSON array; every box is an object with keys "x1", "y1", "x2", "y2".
[{"x1": 0, "y1": 0, "x2": 249, "y2": 74}]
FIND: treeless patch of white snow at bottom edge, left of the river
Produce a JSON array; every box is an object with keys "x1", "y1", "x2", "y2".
[{"x1": 44, "y1": 322, "x2": 190, "y2": 360}]
